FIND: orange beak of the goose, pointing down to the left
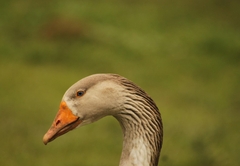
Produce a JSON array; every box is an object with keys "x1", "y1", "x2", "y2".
[{"x1": 43, "y1": 101, "x2": 81, "y2": 145}]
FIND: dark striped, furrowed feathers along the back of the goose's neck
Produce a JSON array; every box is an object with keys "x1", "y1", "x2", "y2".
[{"x1": 112, "y1": 75, "x2": 163, "y2": 166}]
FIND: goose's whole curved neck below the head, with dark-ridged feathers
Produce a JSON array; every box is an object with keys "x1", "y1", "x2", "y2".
[{"x1": 115, "y1": 78, "x2": 163, "y2": 166}]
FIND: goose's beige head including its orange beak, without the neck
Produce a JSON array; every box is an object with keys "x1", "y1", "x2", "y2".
[{"x1": 43, "y1": 74, "x2": 123, "y2": 144}]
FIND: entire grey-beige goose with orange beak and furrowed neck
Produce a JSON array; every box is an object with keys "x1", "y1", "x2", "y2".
[{"x1": 43, "y1": 74, "x2": 163, "y2": 166}]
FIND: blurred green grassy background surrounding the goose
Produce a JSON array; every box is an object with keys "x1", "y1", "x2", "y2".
[{"x1": 0, "y1": 0, "x2": 240, "y2": 166}]
